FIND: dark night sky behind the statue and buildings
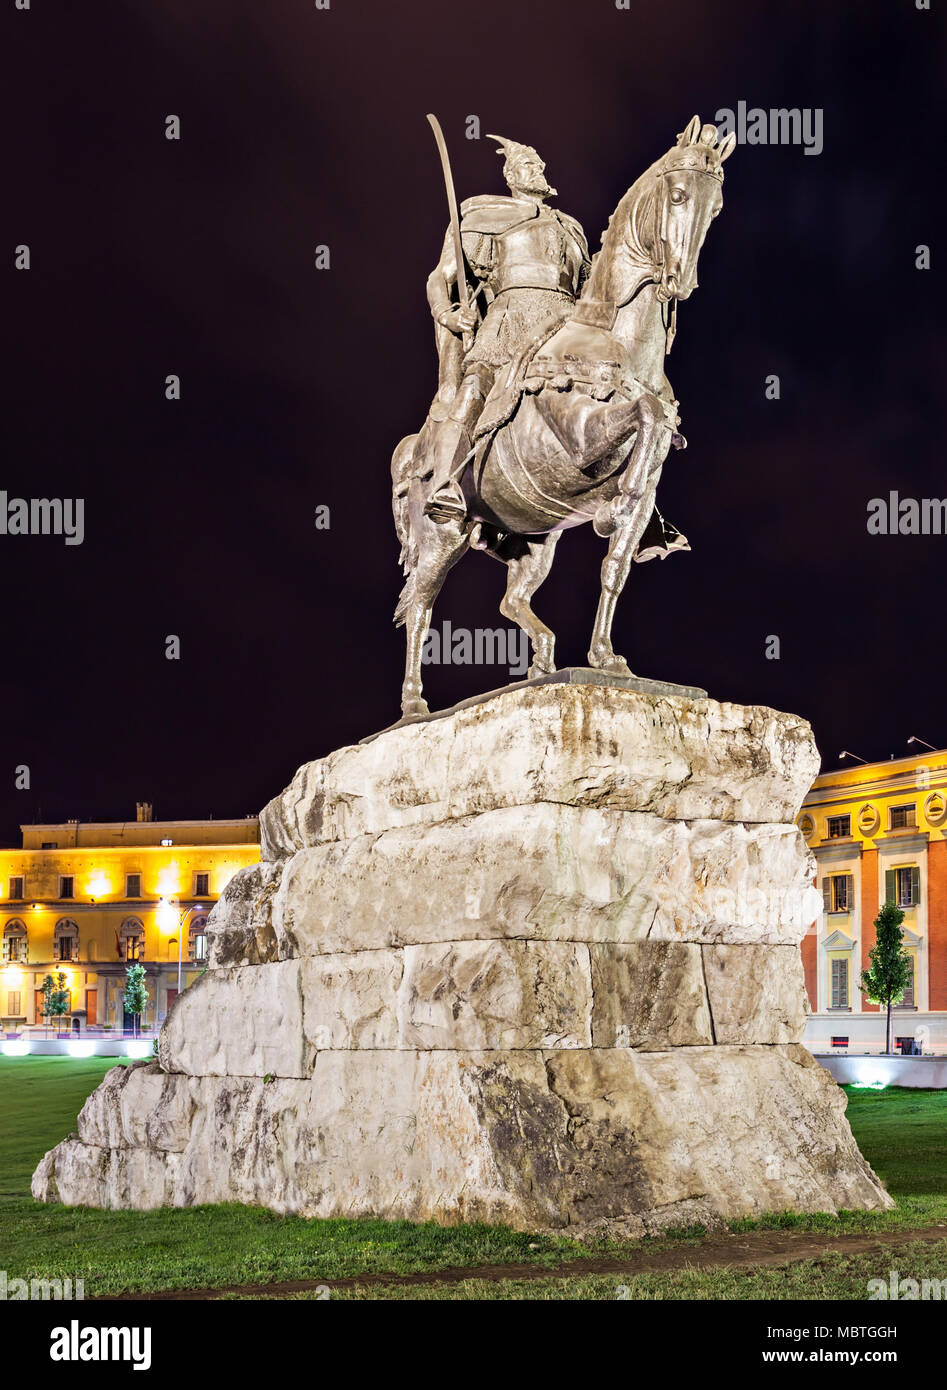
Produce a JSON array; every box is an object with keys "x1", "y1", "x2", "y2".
[{"x1": 0, "y1": 0, "x2": 947, "y2": 842}]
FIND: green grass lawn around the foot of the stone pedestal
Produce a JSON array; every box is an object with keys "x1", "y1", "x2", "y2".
[{"x1": 0, "y1": 1056, "x2": 947, "y2": 1300}]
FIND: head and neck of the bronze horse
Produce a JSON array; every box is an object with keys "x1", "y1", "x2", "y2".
[{"x1": 583, "y1": 115, "x2": 737, "y2": 307}]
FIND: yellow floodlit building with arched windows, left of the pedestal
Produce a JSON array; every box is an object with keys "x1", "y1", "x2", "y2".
[{"x1": 0, "y1": 802, "x2": 260, "y2": 1036}]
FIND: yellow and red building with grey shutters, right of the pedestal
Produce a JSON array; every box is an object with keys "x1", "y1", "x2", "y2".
[{"x1": 798, "y1": 749, "x2": 947, "y2": 1054}]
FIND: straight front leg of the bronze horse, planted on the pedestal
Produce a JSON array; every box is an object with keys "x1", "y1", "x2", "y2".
[{"x1": 588, "y1": 398, "x2": 672, "y2": 676}]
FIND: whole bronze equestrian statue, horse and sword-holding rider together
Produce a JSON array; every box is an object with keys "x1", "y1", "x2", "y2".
[{"x1": 392, "y1": 117, "x2": 736, "y2": 720}]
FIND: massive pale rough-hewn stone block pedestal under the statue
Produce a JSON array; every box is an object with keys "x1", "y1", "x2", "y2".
[{"x1": 33, "y1": 682, "x2": 890, "y2": 1236}]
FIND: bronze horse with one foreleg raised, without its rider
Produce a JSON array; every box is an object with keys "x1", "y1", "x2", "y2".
[{"x1": 392, "y1": 117, "x2": 736, "y2": 719}]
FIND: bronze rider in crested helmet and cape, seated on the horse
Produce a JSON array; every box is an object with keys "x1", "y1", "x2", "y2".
[{"x1": 424, "y1": 135, "x2": 590, "y2": 521}]
